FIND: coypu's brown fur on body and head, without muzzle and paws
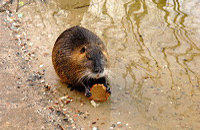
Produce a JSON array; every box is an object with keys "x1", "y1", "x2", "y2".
[{"x1": 52, "y1": 26, "x2": 109, "y2": 86}]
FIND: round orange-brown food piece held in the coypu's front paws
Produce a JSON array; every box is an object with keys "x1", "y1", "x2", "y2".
[{"x1": 90, "y1": 84, "x2": 110, "y2": 102}]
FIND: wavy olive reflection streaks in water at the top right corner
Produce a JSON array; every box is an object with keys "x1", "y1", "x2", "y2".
[{"x1": 153, "y1": 0, "x2": 200, "y2": 104}]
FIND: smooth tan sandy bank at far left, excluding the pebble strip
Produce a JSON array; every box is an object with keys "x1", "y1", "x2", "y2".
[{"x1": 0, "y1": 10, "x2": 54, "y2": 130}]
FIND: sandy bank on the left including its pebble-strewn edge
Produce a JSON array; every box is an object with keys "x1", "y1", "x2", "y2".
[{"x1": 0, "y1": 3, "x2": 67, "y2": 130}]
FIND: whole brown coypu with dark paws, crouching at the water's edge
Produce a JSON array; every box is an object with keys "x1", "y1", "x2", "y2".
[{"x1": 52, "y1": 26, "x2": 111, "y2": 97}]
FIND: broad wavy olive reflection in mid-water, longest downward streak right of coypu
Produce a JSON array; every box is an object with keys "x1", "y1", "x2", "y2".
[{"x1": 122, "y1": 0, "x2": 155, "y2": 118}]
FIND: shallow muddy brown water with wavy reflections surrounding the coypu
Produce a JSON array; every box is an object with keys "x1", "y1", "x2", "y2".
[{"x1": 21, "y1": 0, "x2": 200, "y2": 129}]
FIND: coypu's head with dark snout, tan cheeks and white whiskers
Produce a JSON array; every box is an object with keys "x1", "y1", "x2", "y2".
[{"x1": 72, "y1": 44, "x2": 109, "y2": 79}]
